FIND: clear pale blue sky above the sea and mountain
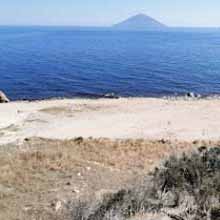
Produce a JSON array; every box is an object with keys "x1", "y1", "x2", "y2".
[{"x1": 0, "y1": 0, "x2": 220, "y2": 26}]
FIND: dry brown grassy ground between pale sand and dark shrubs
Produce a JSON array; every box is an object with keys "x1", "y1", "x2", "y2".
[{"x1": 0, "y1": 138, "x2": 220, "y2": 220}]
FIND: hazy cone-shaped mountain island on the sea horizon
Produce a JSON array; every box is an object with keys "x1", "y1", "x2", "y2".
[{"x1": 113, "y1": 14, "x2": 167, "y2": 31}]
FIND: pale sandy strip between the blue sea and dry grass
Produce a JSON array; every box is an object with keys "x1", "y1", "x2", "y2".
[{"x1": 0, "y1": 98, "x2": 220, "y2": 144}]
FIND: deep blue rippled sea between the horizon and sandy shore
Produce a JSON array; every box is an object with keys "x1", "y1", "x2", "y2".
[{"x1": 0, "y1": 27, "x2": 220, "y2": 100}]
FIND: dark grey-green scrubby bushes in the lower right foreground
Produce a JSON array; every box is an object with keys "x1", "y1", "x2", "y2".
[{"x1": 72, "y1": 147, "x2": 220, "y2": 220}]
